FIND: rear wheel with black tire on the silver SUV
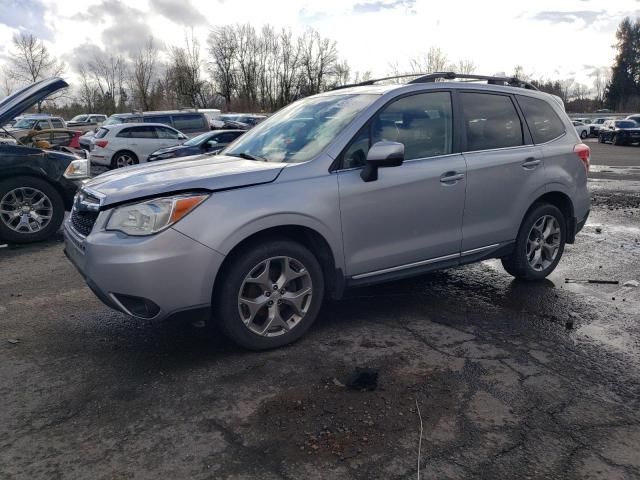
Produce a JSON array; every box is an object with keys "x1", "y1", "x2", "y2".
[{"x1": 502, "y1": 203, "x2": 567, "y2": 281}]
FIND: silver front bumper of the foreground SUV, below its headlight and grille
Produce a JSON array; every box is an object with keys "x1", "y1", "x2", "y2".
[{"x1": 64, "y1": 220, "x2": 224, "y2": 319}]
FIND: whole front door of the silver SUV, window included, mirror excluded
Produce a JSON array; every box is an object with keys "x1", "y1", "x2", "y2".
[{"x1": 338, "y1": 91, "x2": 466, "y2": 276}]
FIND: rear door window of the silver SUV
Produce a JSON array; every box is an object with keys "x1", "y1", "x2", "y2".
[{"x1": 460, "y1": 92, "x2": 524, "y2": 152}]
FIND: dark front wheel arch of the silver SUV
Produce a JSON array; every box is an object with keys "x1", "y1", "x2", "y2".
[{"x1": 212, "y1": 224, "x2": 344, "y2": 299}]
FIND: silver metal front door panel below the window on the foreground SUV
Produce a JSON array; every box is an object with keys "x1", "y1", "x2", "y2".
[{"x1": 338, "y1": 154, "x2": 465, "y2": 275}]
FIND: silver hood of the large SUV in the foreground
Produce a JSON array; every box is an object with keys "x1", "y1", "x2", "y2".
[{"x1": 85, "y1": 155, "x2": 286, "y2": 207}]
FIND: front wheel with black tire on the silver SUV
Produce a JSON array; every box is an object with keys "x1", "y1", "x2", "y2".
[{"x1": 213, "y1": 239, "x2": 324, "y2": 350}]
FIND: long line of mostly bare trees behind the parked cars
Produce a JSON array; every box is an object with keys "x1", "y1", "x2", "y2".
[{"x1": 0, "y1": 18, "x2": 640, "y2": 116}]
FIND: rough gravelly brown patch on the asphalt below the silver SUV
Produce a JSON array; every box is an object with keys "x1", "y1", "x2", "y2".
[{"x1": 251, "y1": 370, "x2": 461, "y2": 460}]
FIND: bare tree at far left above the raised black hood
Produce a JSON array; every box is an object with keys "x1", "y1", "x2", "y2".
[{"x1": 7, "y1": 32, "x2": 65, "y2": 112}]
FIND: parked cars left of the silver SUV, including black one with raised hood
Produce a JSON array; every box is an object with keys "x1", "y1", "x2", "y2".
[{"x1": 0, "y1": 78, "x2": 265, "y2": 243}]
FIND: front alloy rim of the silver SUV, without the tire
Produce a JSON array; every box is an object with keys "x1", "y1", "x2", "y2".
[{"x1": 238, "y1": 256, "x2": 313, "y2": 337}]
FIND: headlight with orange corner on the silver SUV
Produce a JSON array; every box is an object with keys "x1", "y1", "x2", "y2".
[{"x1": 106, "y1": 193, "x2": 209, "y2": 236}]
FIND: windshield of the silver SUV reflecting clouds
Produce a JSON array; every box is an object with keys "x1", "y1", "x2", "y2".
[{"x1": 224, "y1": 94, "x2": 378, "y2": 163}]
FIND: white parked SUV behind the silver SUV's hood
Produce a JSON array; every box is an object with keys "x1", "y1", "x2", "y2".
[{"x1": 89, "y1": 123, "x2": 189, "y2": 168}]
